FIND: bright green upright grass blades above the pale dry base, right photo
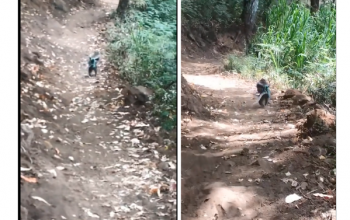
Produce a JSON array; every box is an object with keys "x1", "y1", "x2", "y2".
[{"x1": 254, "y1": 0, "x2": 336, "y2": 77}]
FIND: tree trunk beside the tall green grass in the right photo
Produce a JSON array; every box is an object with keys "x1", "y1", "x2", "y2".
[{"x1": 241, "y1": 0, "x2": 259, "y2": 53}]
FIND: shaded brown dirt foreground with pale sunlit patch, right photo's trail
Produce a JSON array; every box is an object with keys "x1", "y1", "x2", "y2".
[{"x1": 181, "y1": 137, "x2": 332, "y2": 220}]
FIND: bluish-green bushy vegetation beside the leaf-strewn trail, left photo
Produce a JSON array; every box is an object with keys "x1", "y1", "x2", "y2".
[{"x1": 109, "y1": 0, "x2": 177, "y2": 130}]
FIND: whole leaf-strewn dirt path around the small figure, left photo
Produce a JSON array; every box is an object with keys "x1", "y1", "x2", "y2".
[{"x1": 21, "y1": 0, "x2": 176, "y2": 220}]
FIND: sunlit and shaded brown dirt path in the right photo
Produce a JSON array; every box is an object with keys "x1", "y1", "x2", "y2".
[{"x1": 181, "y1": 58, "x2": 335, "y2": 220}]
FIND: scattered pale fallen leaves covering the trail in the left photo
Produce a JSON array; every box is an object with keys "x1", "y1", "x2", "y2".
[{"x1": 21, "y1": 2, "x2": 177, "y2": 219}]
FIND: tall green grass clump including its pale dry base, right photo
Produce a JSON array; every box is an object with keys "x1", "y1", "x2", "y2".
[{"x1": 228, "y1": 0, "x2": 336, "y2": 105}]
